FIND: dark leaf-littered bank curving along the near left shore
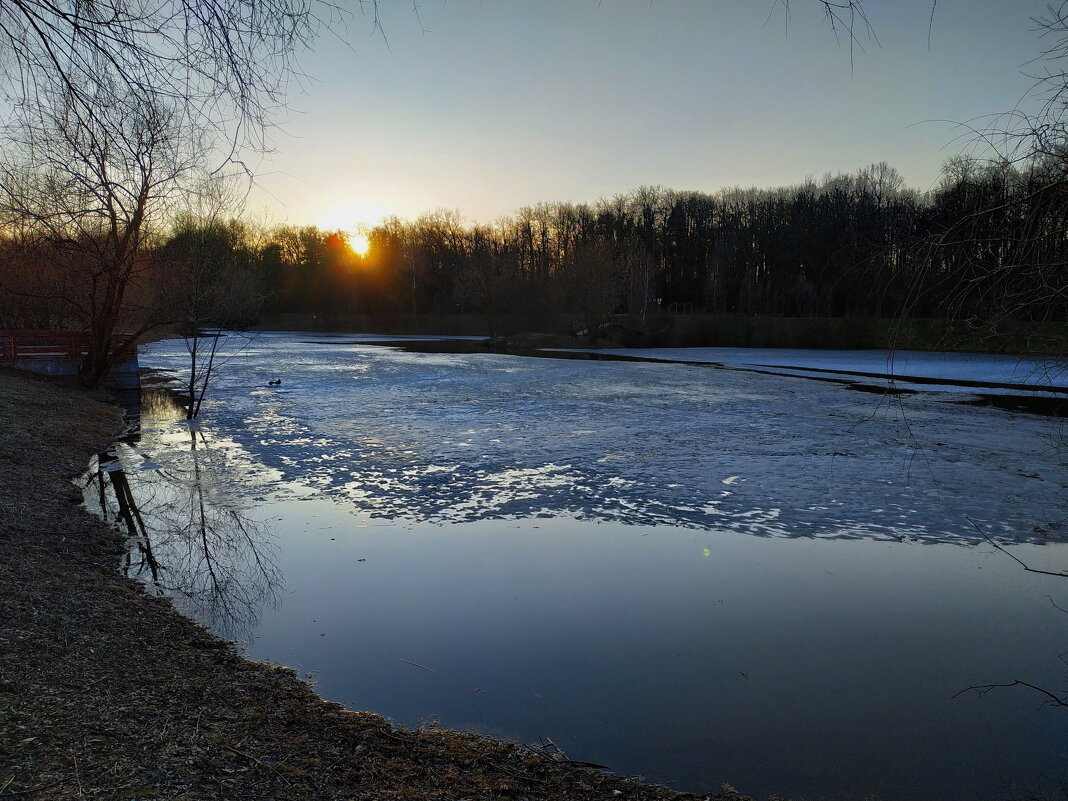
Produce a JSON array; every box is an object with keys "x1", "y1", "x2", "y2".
[{"x1": 0, "y1": 372, "x2": 738, "y2": 801}]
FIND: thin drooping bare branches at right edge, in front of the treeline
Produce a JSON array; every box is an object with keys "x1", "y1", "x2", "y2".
[{"x1": 888, "y1": 0, "x2": 1068, "y2": 357}]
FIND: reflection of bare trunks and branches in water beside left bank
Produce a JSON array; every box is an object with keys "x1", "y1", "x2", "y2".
[{"x1": 85, "y1": 396, "x2": 282, "y2": 641}]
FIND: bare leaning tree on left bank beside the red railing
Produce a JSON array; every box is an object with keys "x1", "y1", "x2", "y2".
[{"x1": 0, "y1": 79, "x2": 202, "y2": 384}]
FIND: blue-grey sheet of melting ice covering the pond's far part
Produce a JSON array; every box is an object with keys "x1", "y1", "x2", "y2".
[{"x1": 142, "y1": 333, "x2": 1068, "y2": 541}]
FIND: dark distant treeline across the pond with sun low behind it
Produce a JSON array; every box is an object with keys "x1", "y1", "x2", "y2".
[{"x1": 0, "y1": 157, "x2": 1068, "y2": 343}]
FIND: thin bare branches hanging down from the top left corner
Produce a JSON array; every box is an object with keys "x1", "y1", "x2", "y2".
[{"x1": 0, "y1": 0, "x2": 341, "y2": 154}]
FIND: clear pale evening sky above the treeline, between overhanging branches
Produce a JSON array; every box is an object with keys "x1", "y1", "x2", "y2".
[{"x1": 249, "y1": 0, "x2": 1046, "y2": 230}]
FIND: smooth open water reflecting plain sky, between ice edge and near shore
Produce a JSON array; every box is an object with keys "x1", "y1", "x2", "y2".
[{"x1": 249, "y1": 499, "x2": 1068, "y2": 799}]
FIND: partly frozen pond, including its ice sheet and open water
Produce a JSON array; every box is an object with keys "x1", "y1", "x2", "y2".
[{"x1": 87, "y1": 333, "x2": 1068, "y2": 799}]
